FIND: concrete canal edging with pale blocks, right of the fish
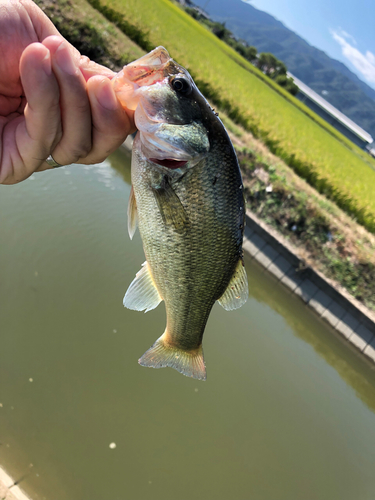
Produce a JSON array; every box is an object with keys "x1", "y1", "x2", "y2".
[{"x1": 243, "y1": 212, "x2": 375, "y2": 362}]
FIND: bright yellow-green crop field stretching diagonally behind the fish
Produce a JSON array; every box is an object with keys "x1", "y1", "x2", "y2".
[{"x1": 86, "y1": 0, "x2": 375, "y2": 232}]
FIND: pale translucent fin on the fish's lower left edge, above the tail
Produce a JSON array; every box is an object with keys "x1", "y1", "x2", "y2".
[{"x1": 124, "y1": 261, "x2": 163, "y2": 312}]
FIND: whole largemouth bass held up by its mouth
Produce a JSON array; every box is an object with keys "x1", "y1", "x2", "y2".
[{"x1": 113, "y1": 47, "x2": 248, "y2": 380}]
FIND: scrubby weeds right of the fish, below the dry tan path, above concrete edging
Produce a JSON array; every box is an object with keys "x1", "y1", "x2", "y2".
[{"x1": 237, "y1": 148, "x2": 375, "y2": 310}]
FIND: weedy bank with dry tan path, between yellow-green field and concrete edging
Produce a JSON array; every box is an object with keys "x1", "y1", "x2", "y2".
[{"x1": 221, "y1": 113, "x2": 375, "y2": 311}]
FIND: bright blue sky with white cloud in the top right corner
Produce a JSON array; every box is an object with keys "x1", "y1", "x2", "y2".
[{"x1": 245, "y1": 0, "x2": 375, "y2": 88}]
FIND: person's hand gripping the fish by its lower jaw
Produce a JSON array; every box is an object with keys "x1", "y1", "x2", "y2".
[{"x1": 0, "y1": 0, "x2": 135, "y2": 184}]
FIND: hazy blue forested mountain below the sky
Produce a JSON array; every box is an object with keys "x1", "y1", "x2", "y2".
[{"x1": 193, "y1": 0, "x2": 375, "y2": 138}]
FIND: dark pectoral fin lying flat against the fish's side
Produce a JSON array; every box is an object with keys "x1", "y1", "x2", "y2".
[{"x1": 154, "y1": 176, "x2": 189, "y2": 233}]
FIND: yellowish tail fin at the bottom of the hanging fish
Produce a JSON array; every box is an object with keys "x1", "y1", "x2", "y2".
[{"x1": 138, "y1": 335, "x2": 206, "y2": 380}]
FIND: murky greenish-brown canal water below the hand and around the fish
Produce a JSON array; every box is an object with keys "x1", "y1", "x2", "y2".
[{"x1": 0, "y1": 148, "x2": 375, "y2": 500}]
